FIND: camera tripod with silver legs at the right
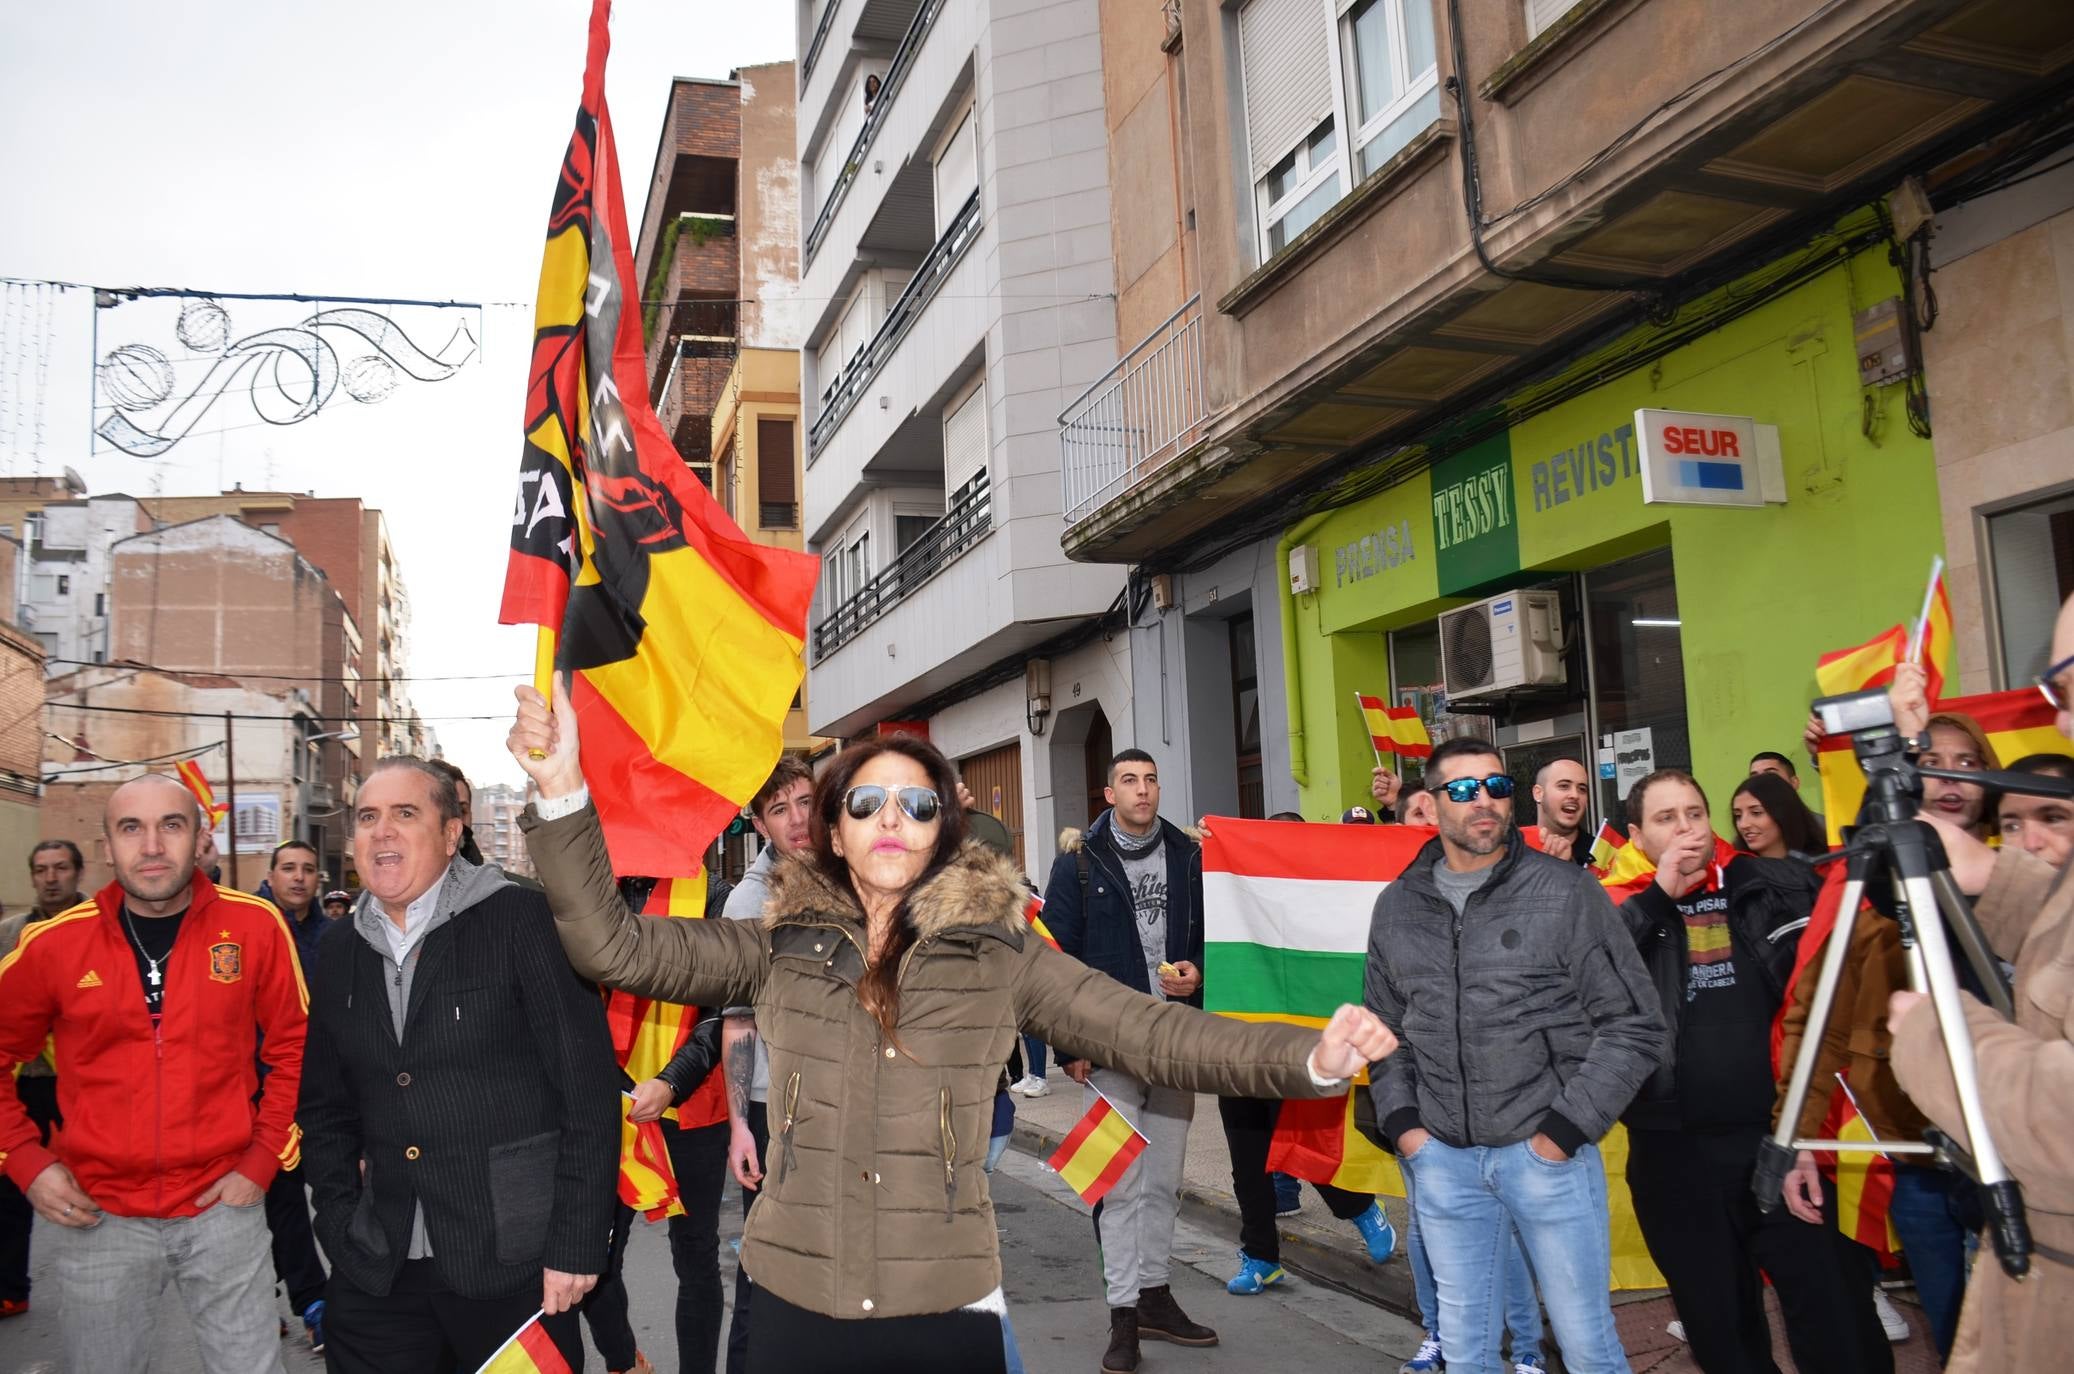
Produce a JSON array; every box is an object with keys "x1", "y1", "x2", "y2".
[{"x1": 1750, "y1": 693, "x2": 2074, "y2": 1279}]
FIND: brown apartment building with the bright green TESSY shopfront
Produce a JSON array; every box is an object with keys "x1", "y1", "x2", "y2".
[{"x1": 1060, "y1": 0, "x2": 2074, "y2": 820}]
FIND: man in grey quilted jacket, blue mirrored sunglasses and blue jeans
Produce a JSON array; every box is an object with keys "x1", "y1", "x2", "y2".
[{"x1": 1367, "y1": 739, "x2": 1663, "y2": 1374}]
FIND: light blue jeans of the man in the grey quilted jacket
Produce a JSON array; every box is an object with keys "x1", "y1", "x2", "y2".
[{"x1": 1404, "y1": 1139, "x2": 1628, "y2": 1374}]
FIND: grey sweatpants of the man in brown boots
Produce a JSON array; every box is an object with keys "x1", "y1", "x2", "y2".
[{"x1": 1087, "y1": 1069, "x2": 1195, "y2": 1308}]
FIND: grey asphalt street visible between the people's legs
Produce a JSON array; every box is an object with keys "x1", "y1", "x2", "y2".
[{"x1": 0, "y1": 1150, "x2": 1419, "y2": 1374}]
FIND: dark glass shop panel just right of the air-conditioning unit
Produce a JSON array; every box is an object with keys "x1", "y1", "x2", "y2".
[{"x1": 1585, "y1": 548, "x2": 1692, "y2": 820}]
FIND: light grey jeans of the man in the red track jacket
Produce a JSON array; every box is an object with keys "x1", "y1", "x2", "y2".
[{"x1": 46, "y1": 1204, "x2": 284, "y2": 1374}]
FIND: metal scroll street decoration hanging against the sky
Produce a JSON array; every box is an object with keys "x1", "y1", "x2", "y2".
[{"x1": 93, "y1": 297, "x2": 477, "y2": 459}]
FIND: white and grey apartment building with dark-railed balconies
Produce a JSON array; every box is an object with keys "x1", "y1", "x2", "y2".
[{"x1": 798, "y1": 0, "x2": 1134, "y2": 872}]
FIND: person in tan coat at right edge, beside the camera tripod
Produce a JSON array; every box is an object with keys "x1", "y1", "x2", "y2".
[{"x1": 1887, "y1": 598, "x2": 2074, "y2": 1374}]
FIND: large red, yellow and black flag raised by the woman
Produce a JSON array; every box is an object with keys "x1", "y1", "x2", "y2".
[{"x1": 498, "y1": 0, "x2": 817, "y2": 874}]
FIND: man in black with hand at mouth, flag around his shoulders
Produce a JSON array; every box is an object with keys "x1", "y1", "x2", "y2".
[{"x1": 1607, "y1": 770, "x2": 1894, "y2": 1374}]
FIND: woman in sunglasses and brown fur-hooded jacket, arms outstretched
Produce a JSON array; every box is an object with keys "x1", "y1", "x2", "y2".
[{"x1": 508, "y1": 683, "x2": 1396, "y2": 1374}]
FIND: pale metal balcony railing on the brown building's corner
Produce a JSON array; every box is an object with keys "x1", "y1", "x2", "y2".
[{"x1": 1058, "y1": 297, "x2": 1209, "y2": 525}]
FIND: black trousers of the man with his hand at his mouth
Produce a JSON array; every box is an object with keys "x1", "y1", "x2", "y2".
[{"x1": 1628, "y1": 1127, "x2": 1894, "y2": 1374}]
